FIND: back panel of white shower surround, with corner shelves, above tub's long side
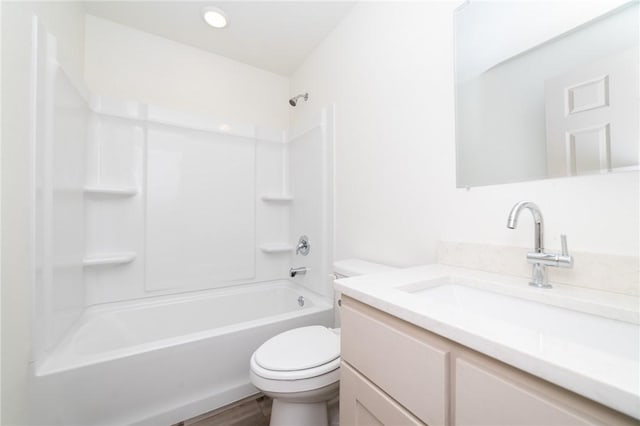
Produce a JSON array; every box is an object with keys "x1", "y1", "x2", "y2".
[{"x1": 85, "y1": 103, "x2": 290, "y2": 305}]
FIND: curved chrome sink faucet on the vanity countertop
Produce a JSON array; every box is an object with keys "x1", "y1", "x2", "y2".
[{"x1": 507, "y1": 201, "x2": 573, "y2": 288}]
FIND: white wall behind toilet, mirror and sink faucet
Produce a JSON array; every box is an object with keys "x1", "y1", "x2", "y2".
[{"x1": 291, "y1": 2, "x2": 640, "y2": 266}]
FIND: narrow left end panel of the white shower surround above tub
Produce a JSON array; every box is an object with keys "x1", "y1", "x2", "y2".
[{"x1": 30, "y1": 18, "x2": 89, "y2": 366}]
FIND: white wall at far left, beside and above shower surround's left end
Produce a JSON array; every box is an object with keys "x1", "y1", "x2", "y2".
[{"x1": 1, "y1": 2, "x2": 84, "y2": 425}]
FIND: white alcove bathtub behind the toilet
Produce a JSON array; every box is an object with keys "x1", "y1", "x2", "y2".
[{"x1": 32, "y1": 281, "x2": 333, "y2": 426}]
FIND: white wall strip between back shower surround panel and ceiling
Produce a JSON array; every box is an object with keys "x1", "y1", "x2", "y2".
[{"x1": 85, "y1": 15, "x2": 289, "y2": 129}]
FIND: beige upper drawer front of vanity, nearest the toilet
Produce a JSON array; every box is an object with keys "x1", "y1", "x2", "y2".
[{"x1": 341, "y1": 297, "x2": 449, "y2": 426}]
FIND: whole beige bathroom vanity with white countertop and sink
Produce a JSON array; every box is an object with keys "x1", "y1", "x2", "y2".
[{"x1": 336, "y1": 265, "x2": 640, "y2": 426}]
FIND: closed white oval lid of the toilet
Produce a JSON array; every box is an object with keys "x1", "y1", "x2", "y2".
[{"x1": 255, "y1": 325, "x2": 340, "y2": 371}]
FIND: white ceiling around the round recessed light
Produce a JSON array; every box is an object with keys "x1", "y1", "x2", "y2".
[{"x1": 85, "y1": 1, "x2": 355, "y2": 76}]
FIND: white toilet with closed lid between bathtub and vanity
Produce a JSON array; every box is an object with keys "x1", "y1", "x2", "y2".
[{"x1": 250, "y1": 259, "x2": 394, "y2": 426}]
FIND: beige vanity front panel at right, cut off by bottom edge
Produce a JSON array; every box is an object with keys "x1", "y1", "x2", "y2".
[{"x1": 455, "y1": 358, "x2": 603, "y2": 426}]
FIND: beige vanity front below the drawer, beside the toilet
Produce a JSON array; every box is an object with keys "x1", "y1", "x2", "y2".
[{"x1": 340, "y1": 362, "x2": 424, "y2": 426}]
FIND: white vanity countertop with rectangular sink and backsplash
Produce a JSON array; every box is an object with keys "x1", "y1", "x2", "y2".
[{"x1": 335, "y1": 265, "x2": 640, "y2": 419}]
